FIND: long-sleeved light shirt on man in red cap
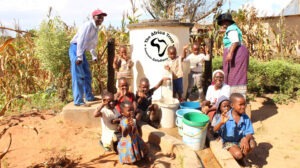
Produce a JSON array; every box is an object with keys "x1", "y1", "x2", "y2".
[{"x1": 71, "y1": 19, "x2": 99, "y2": 60}]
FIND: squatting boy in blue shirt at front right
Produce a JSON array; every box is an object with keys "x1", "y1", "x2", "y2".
[{"x1": 214, "y1": 93, "x2": 256, "y2": 163}]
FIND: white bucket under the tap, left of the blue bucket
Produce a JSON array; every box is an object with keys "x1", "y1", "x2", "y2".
[{"x1": 158, "y1": 99, "x2": 179, "y2": 128}]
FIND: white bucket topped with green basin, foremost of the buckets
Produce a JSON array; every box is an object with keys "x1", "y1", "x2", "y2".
[{"x1": 182, "y1": 112, "x2": 209, "y2": 151}]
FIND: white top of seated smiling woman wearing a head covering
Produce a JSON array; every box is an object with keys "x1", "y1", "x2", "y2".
[{"x1": 205, "y1": 84, "x2": 230, "y2": 105}]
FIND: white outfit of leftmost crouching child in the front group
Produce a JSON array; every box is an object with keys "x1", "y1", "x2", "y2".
[{"x1": 101, "y1": 107, "x2": 120, "y2": 147}]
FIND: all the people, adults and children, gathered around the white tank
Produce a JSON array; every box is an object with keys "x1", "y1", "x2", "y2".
[{"x1": 69, "y1": 9, "x2": 255, "y2": 163}]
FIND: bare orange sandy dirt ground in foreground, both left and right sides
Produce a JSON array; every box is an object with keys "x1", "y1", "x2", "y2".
[{"x1": 0, "y1": 97, "x2": 300, "y2": 168}]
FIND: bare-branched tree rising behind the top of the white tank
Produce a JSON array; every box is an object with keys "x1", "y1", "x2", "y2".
[{"x1": 142, "y1": 0, "x2": 223, "y2": 22}]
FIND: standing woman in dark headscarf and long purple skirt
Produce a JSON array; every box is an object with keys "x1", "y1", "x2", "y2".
[{"x1": 217, "y1": 13, "x2": 249, "y2": 98}]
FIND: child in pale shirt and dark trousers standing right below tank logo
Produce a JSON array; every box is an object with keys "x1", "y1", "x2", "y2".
[{"x1": 165, "y1": 46, "x2": 183, "y2": 102}]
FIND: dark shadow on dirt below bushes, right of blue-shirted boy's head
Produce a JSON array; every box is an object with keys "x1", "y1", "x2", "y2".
[{"x1": 251, "y1": 97, "x2": 278, "y2": 123}]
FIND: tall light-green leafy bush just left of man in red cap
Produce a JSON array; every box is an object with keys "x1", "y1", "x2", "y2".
[{"x1": 34, "y1": 8, "x2": 74, "y2": 100}]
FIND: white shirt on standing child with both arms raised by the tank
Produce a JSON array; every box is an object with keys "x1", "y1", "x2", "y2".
[{"x1": 184, "y1": 53, "x2": 209, "y2": 72}]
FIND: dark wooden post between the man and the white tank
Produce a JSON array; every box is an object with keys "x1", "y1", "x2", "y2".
[{"x1": 107, "y1": 38, "x2": 116, "y2": 93}]
